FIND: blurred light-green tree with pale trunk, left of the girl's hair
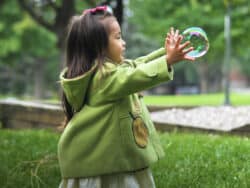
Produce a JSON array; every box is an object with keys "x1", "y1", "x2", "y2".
[{"x1": 14, "y1": 14, "x2": 59, "y2": 99}]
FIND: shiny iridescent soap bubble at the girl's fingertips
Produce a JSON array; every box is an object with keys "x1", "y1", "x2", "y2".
[{"x1": 182, "y1": 27, "x2": 209, "y2": 58}]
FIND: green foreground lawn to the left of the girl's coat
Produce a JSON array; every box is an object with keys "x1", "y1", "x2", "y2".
[{"x1": 0, "y1": 129, "x2": 60, "y2": 188}]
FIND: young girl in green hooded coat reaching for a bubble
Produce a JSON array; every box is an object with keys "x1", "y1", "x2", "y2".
[{"x1": 58, "y1": 6, "x2": 194, "y2": 188}]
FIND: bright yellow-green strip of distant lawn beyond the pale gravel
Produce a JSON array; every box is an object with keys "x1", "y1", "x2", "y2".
[{"x1": 144, "y1": 93, "x2": 250, "y2": 106}]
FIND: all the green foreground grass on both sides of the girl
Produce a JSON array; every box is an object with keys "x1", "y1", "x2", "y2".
[{"x1": 0, "y1": 129, "x2": 250, "y2": 188}]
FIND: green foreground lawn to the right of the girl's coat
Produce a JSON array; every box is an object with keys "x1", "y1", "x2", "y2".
[{"x1": 153, "y1": 134, "x2": 250, "y2": 188}]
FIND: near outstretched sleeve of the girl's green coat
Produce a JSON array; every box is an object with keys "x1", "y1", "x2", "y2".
[{"x1": 94, "y1": 56, "x2": 173, "y2": 103}]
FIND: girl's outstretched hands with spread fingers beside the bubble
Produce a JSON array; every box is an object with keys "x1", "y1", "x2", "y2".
[{"x1": 165, "y1": 27, "x2": 195, "y2": 65}]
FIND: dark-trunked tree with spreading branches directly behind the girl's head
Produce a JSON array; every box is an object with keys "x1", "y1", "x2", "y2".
[{"x1": 18, "y1": 0, "x2": 123, "y2": 62}]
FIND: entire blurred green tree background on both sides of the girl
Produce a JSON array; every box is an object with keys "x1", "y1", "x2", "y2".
[{"x1": 0, "y1": 0, "x2": 250, "y2": 98}]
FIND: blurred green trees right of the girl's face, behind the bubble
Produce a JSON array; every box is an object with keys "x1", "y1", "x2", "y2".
[{"x1": 130, "y1": 0, "x2": 250, "y2": 93}]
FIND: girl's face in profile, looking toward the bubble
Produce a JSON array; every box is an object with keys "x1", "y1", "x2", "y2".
[{"x1": 107, "y1": 19, "x2": 126, "y2": 63}]
